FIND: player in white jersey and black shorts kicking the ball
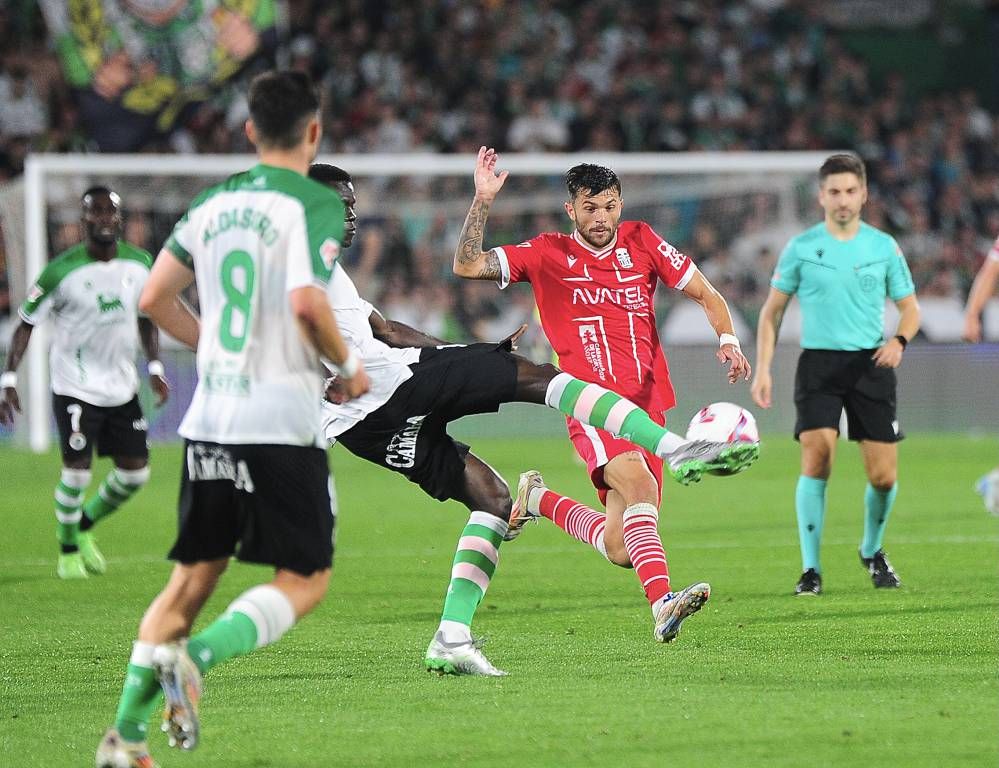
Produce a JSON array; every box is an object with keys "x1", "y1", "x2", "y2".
[{"x1": 309, "y1": 164, "x2": 756, "y2": 676}]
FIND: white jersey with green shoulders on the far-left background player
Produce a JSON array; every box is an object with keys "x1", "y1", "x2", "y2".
[{"x1": 18, "y1": 240, "x2": 153, "y2": 406}]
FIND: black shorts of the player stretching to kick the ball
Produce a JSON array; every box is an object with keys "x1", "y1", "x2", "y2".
[{"x1": 337, "y1": 344, "x2": 517, "y2": 501}]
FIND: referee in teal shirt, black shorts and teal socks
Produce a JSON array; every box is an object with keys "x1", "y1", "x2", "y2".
[{"x1": 751, "y1": 154, "x2": 919, "y2": 595}]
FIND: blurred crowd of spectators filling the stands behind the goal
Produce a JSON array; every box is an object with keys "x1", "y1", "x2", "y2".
[{"x1": 0, "y1": 0, "x2": 999, "y2": 338}]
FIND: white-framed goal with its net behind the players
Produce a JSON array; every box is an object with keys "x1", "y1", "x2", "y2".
[{"x1": 0, "y1": 153, "x2": 844, "y2": 450}]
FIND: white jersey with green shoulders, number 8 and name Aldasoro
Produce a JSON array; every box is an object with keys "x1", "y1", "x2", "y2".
[{"x1": 164, "y1": 165, "x2": 344, "y2": 446}]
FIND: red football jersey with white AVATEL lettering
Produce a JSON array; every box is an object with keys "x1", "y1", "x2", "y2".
[{"x1": 493, "y1": 221, "x2": 696, "y2": 411}]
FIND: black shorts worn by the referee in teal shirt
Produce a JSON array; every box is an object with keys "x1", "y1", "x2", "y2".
[{"x1": 794, "y1": 349, "x2": 905, "y2": 443}]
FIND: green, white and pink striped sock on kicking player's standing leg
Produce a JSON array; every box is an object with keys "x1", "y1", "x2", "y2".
[{"x1": 439, "y1": 512, "x2": 507, "y2": 642}]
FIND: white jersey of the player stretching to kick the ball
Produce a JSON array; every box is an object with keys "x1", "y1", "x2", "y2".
[{"x1": 322, "y1": 269, "x2": 420, "y2": 442}]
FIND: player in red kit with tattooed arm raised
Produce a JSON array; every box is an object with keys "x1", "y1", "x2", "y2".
[{"x1": 454, "y1": 147, "x2": 759, "y2": 642}]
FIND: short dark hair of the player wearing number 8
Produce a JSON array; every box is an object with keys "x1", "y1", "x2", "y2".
[{"x1": 247, "y1": 70, "x2": 319, "y2": 149}]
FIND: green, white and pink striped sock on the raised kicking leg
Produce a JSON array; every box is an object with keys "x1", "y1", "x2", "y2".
[{"x1": 545, "y1": 373, "x2": 687, "y2": 456}]
